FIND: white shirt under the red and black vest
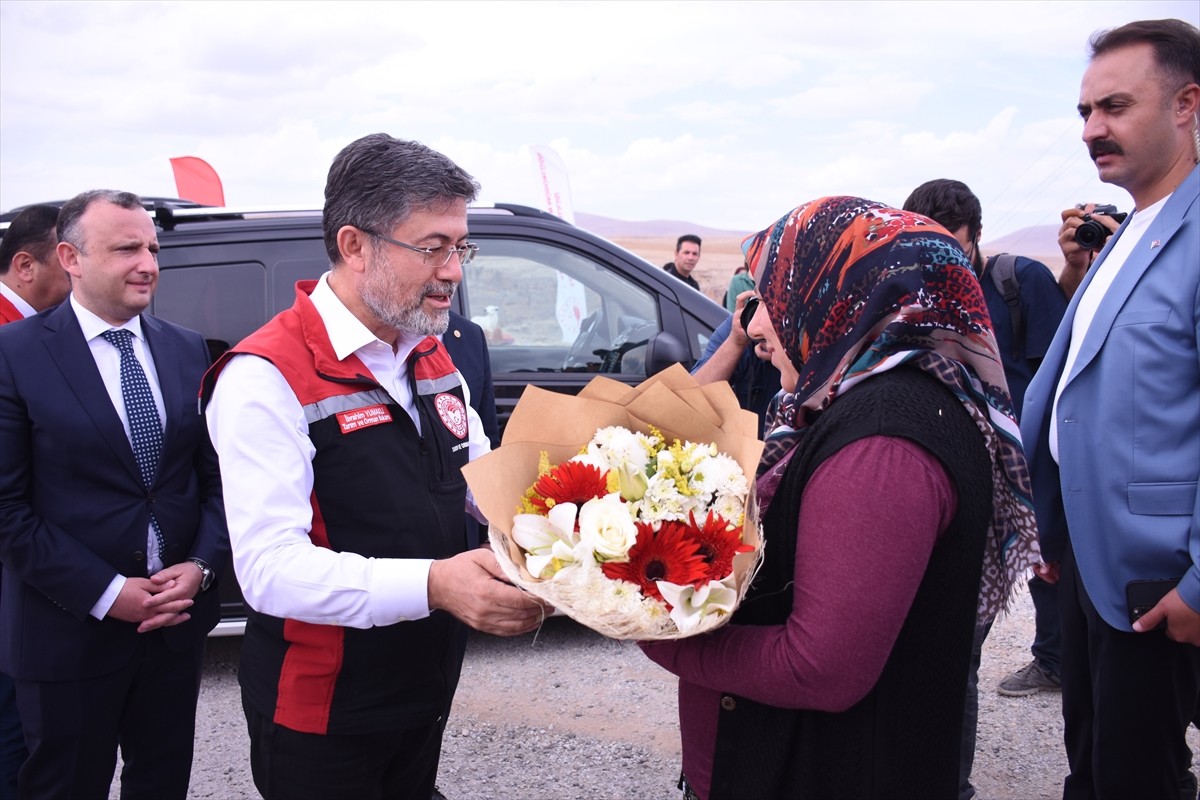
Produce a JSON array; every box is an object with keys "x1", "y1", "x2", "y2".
[{"x1": 205, "y1": 272, "x2": 491, "y2": 628}]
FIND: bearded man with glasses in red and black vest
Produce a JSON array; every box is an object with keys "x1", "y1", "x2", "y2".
[{"x1": 202, "y1": 133, "x2": 544, "y2": 800}]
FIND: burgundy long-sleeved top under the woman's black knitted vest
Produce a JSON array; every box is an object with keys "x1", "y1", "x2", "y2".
[{"x1": 642, "y1": 437, "x2": 958, "y2": 799}]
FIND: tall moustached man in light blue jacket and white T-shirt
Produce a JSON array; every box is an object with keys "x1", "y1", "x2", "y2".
[{"x1": 1021, "y1": 19, "x2": 1200, "y2": 800}]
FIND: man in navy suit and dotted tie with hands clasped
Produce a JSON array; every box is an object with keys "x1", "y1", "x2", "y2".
[{"x1": 0, "y1": 191, "x2": 229, "y2": 800}]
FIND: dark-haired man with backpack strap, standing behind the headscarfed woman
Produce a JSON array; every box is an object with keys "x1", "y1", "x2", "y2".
[{"x1": 904, "y1": 179, "x2": 1067, "y2": 800}]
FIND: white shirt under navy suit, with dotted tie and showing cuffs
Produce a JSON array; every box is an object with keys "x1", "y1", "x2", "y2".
[{"x1": 71, "y1": 295, "x2": 167, "y2": 619}]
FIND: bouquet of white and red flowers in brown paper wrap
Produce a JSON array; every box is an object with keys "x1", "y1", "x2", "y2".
[{"x1": 464, "y1": 366, "x2": 762, "y2": 639}]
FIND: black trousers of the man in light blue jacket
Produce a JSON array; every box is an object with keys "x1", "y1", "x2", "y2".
[{"x1": 1058, "y1": 543, "x2": 1200, "y2": 800}]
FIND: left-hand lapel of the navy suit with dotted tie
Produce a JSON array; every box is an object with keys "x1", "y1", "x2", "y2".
[{"x1": 44, "y1": 302, "x2": 142, "y2": 485}]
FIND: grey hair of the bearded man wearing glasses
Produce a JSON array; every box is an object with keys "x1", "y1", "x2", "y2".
[{"x1": 322, "y1": 133, "x2": 479, "y2": 264}]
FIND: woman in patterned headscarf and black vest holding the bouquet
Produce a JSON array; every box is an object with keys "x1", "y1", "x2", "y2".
[{"x1": 643, "y1": 197, "x2": 1038, "y2": 800}]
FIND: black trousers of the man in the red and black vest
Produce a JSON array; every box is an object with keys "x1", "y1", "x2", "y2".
[{"x1": 241, "y1": 696, "x2": 445, "y2": 800}]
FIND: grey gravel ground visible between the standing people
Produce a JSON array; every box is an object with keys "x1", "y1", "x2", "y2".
[{"x1": 110, "y1": 582, "x2": 1200, "y2": 800}]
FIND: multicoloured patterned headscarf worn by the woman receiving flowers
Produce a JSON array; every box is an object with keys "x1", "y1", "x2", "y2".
[{"x1": 742, "y1": 197, "x2": 1040, "y2": 620}]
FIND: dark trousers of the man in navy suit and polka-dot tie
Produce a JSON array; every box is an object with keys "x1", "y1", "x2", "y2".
[{"x1": 17, "y1": 631, "x2": 204, "y2": 800}]
